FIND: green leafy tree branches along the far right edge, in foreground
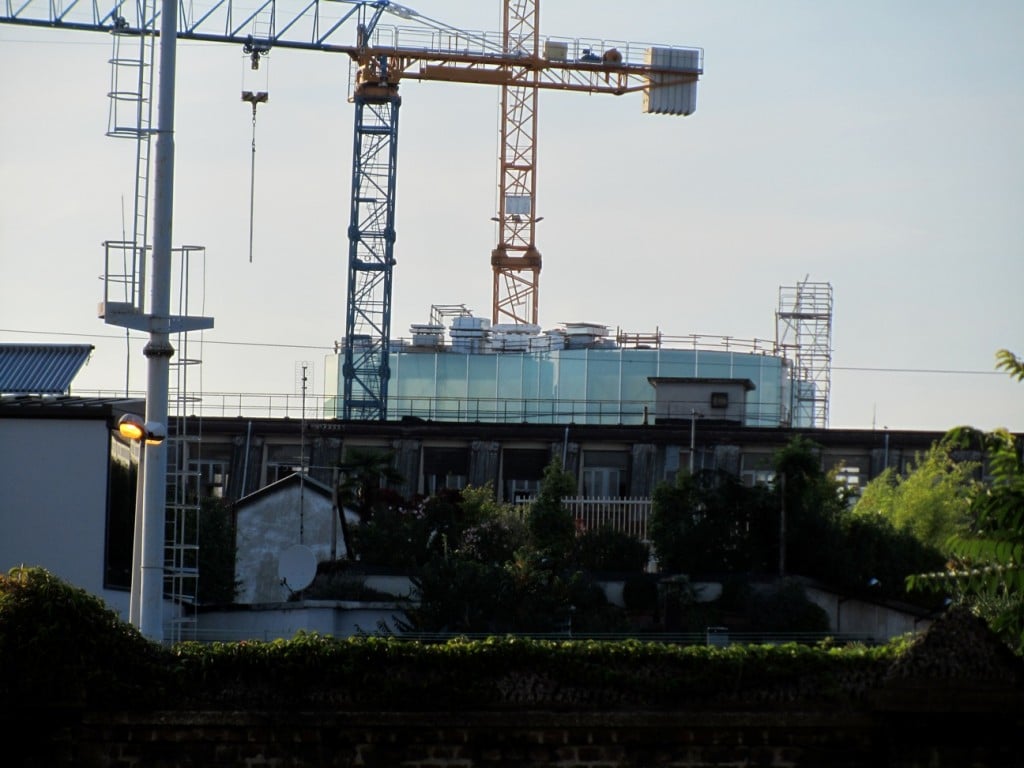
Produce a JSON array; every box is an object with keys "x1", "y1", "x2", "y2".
[{"x1": 908, "y1": 349, "x2": 1024, "y2": 653}]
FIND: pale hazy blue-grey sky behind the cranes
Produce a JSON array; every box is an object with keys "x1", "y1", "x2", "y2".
[{"x1": 0, "y1": 0, "x2": 1024, "y2": 431}]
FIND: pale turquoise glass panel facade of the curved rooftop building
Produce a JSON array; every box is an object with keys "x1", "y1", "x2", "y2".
[{"x1": 325, "y1": 347, "x2": 794, "y2": 427}]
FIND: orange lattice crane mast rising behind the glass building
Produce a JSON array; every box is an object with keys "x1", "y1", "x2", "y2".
[{"x1": 490, "y1": 0, "x2": 541, "y2": 325}]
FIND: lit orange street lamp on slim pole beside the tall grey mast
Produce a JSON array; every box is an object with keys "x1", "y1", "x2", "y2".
[{"x1": 118, "y1": 414, "x2": 167, "y2": 630}]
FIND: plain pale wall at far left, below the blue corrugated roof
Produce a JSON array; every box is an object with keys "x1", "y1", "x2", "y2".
[{"x1": 0, "y1": 419, "x2": 128, "y2": 615}]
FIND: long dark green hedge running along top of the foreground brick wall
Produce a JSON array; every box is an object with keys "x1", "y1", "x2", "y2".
[{"x1": 0, "y1": 568, "x2": 907, "y2": 711}]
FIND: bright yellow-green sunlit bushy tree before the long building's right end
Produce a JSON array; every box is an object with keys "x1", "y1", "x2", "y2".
[{"x1": 853, "y1": 442, "x2": 978, "y2": 549}]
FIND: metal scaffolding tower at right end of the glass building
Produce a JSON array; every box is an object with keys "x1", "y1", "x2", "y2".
[{"x1": 775, "y1": 278, "x2": 833, "y2": 428}]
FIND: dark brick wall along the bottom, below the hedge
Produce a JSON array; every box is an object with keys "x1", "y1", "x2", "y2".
[{"x1": 16, "y1": 700, "x2": 1024, "y2": 768}]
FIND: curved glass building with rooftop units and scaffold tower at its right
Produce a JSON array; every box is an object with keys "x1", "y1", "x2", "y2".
[{"x1": 324, "y1": 280, "x2": 833, "y2": 427}]
